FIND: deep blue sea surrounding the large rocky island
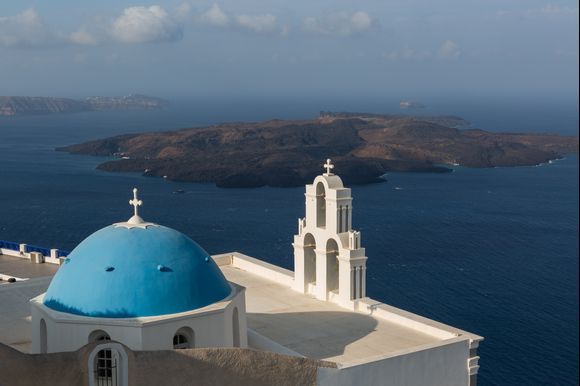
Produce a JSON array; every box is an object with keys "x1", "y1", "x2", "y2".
[{"x1": 0, "y1": 101, "x2": 578, "y2": 385}]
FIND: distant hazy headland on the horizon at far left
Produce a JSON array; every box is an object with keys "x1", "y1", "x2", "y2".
[{"x1": 0, "y1": 94, "x2": 168, "y2": 116}]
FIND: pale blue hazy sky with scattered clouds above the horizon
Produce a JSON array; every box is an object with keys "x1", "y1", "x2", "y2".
[{"x1": 0, "y1": 0, "x2": 578, "y2": 98}]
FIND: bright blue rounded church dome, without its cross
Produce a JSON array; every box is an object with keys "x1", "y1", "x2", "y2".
[{"x1": 44, "y1": 225, "x2": 231, "y2": 318}]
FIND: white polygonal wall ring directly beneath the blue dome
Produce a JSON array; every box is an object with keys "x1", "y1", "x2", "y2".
[{"x1": 31, "y1": 285, "x2": 247, "y2": 353}]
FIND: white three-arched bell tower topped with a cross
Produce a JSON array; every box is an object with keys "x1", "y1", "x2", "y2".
[{"x1": 293, "y1": 159, "x2": 367, "y2": 306}]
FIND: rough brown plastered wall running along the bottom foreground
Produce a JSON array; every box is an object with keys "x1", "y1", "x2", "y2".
[{"x1": 0, "y1": 343, "x2": 336, "y2": 386}]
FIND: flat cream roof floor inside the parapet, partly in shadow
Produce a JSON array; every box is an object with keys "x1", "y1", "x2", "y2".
[{"x1": 220, "y1": 265, "x2": 444, "y2": 363}]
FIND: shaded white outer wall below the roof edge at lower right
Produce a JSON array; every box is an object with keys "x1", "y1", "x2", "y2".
[{"x1": 317, "y1": 338, "x2": 469, "y2": 386}]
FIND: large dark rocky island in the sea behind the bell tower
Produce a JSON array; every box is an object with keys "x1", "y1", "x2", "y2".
[{"x1": 57, "y1": 112, "x2": 578, "y2": 187}]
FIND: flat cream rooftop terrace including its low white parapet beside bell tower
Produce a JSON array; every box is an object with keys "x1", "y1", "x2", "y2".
[{"x1": 214, "y1": 252, "x2": 483, "y2": 365}]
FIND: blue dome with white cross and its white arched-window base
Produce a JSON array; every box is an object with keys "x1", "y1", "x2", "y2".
[{"x1": 31, "y1": 189, "x2": 247, "y2": 353}]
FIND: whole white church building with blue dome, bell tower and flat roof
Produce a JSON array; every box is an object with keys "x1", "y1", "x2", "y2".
[{"x1": 23, "y1": 160, "x2": 483, "y2": 386}]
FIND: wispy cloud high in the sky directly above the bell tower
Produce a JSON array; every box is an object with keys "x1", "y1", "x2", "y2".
[{"x1": 303, "y1": 11, "x2": 373, "y2": 37}]
